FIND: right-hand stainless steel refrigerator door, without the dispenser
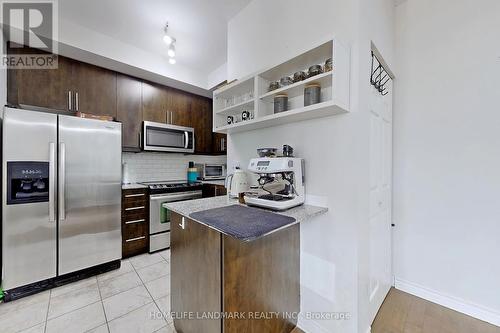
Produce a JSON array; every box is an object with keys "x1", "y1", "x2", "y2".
[{"x1": 58, "y1": 116, "x2": 121, "y2": 275}]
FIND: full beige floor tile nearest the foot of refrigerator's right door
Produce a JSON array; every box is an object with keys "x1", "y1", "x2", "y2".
[{"x1": 48, "y1": 284, "x2": 101, "y2": 319}]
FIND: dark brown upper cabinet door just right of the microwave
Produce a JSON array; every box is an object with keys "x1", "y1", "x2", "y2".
[{"x1": 191, "y1": 96, "x2": 213, "y2": 154}]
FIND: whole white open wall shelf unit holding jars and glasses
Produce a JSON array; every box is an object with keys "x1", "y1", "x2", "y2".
[{"x1": 213, "y1": 39, "x2": 351, "y2": 133}]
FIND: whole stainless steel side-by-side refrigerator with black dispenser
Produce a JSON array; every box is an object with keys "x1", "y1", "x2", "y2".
[{"x1": 2, "y1": 108, "x2": 121, "y2": 290}]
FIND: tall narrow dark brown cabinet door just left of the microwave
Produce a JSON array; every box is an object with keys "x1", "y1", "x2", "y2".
[{"x1": 116, "y1": 74, "x2": 142, "y2": 151}]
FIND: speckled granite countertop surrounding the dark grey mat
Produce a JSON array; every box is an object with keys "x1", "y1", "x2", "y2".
[{"x1": 163, "y1": 196, "x2": 328, "y2": 241}]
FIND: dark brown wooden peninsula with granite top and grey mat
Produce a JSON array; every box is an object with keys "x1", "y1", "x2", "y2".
[{"x1": 164, "y1": 196, "x2": 327, "y2": 333}]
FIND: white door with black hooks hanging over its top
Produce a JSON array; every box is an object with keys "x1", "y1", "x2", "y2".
[{"x1": 369, "y1": 77, "x2": 392, "y2": 322}]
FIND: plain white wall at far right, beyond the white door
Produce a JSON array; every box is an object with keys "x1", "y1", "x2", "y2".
[{"x1": 394, "y1": 0, "x2": 500, "y2": 325}]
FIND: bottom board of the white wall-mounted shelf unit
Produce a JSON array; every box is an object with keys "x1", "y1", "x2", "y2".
[{"x1": 215, "y1": 101, "x2": 347, "y2": 134}]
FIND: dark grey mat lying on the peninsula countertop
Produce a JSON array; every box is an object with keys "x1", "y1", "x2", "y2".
[{"x1": 189, "y1": 205, "x2": 295, "y2": 241}]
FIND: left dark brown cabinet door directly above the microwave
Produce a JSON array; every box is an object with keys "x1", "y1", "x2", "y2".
[{"x1": 142, "y1": 82, "x2": 168, "y2": 123}]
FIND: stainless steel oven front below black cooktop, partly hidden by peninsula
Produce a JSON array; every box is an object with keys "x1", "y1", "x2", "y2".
[{"x1": 149, "y1": 190, "x2": 202, "y2": 252}]
